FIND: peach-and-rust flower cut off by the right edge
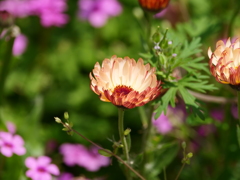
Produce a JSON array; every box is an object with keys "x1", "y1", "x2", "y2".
[{"x1": 208, "y1": 38, "x2": 240, "y2": 87}]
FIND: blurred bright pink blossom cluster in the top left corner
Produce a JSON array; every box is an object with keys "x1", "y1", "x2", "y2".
[{"x1": 0, "y1": 0, "x2": 68, "y2": 27}]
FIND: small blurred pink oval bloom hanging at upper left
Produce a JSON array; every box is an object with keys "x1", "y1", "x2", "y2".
[{"x1": 12, "y1": 34, "x2": 28, "y2": 56}]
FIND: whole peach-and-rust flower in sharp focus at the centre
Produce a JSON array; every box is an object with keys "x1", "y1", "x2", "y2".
[{"x1": 89, "y1": 55, "x2": 161, "y2": 109}]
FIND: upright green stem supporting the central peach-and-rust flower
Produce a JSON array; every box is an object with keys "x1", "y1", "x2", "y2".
[{"x1": 118, "y1": 108, "x2": 131, "y2": 180}]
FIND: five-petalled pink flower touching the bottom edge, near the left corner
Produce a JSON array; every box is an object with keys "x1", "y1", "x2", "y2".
[{"x1": 25, "y1": 156, "x2": 60, "y2": 180}]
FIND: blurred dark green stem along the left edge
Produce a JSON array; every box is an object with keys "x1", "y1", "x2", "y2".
[{"x1": 0, "y1": 38, "x2": 14, "y2": 106}]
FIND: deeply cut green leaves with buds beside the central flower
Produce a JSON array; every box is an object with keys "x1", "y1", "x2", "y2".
[{"x1": 141, "y1": 29, "x2": 215, "y2": 119}]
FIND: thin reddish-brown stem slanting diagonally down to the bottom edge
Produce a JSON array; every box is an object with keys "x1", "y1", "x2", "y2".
[{"x1": 62, "y1": 123, "x2": 146, "y2": 180}]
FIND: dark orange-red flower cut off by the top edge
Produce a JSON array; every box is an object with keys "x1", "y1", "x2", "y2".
[{"x1": 138, "y1": 0, "x2": 169, "y2": 11}]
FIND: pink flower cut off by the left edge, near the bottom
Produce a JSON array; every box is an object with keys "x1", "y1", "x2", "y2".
[{"x1": 0, "y1": 132, "x2": 26, "y2": 157}]
